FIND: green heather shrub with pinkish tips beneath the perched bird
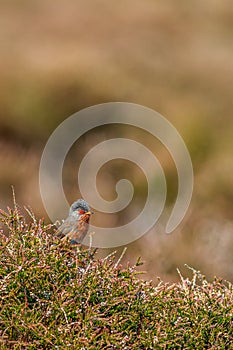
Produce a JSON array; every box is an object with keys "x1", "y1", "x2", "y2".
[{"x1": 0, "y1": 207, "x2": 233, "y2": 350}]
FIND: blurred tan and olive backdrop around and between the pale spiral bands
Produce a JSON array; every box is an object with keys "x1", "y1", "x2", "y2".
[{"x1": 0, "y1": 0, "x2": 233, "y2": 281}]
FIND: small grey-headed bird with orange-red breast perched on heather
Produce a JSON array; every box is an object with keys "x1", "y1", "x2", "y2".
[{"x1": 55, "y1": 199, "x2": 93, "y2": 244}]
